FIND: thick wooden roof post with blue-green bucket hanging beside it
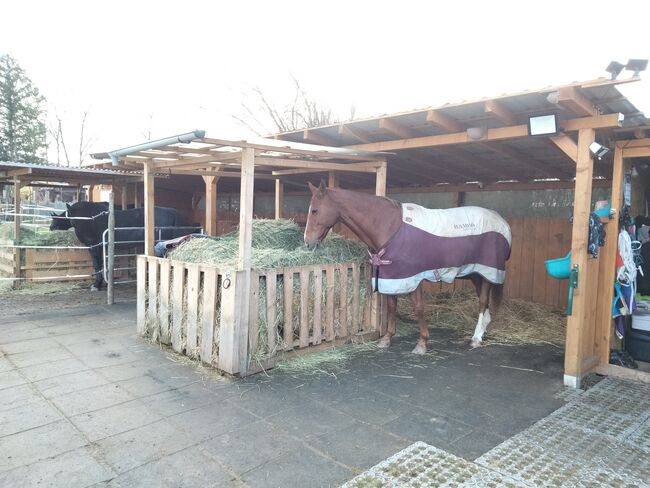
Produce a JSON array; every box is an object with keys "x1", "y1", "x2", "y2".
[{"x1": 564, "y1": 129, "x2": 596, "y2": 388}]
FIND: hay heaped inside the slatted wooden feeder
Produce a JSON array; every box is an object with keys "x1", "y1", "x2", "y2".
[{"x1": 168, "y1": 219, "x2": 367, "y2": 270}]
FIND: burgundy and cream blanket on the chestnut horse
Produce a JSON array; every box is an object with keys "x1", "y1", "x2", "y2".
[{"x1": 370, "y1": 203, "x2": 512, "y2": 295}]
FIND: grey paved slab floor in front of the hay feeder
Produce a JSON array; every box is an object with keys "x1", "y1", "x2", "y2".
[{"x1": 0, "y1": 297, "x2": 644, "y2": 487}]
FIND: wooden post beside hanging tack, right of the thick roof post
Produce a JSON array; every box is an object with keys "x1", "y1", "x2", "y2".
[{"x1": 596, "y1": 145, "x2": 625, "y2": 365}]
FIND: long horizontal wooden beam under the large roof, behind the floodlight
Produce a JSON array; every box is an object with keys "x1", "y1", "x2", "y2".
[{"x1": 346, "y1": 114, "x2": 621, "y2": 151}]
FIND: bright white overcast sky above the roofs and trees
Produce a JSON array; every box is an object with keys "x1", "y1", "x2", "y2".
[{"x1": 0, "y1": 0, "x2": 650, "y2": 162}]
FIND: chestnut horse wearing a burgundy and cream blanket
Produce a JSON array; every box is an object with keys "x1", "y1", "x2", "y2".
[{"x1": 305, "y1": 182, "x2": 511, "y2": 354}]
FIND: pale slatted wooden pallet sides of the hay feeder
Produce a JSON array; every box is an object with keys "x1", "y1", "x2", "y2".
[{"x1": 137, "y1": 256, "x2": 385, "y2": 375}]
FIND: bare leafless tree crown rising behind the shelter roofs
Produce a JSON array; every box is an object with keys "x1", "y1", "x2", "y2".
[{"x1": 233, "y1": 76, "x2": 344, "y2": 136}]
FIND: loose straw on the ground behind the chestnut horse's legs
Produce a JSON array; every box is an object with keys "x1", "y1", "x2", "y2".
[{"x1": 398, "y1": 290, "x2": 566, "y2": 347}]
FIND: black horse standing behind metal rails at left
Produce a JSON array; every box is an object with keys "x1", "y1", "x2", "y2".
[{"x1": 50, "y1": 202, "x2": 187, "y2": 291}]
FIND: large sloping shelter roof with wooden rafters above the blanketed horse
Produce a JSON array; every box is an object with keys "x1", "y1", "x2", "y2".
[{"x1": 274, "y1": 77, "x2": 650, "y2": 186}]
